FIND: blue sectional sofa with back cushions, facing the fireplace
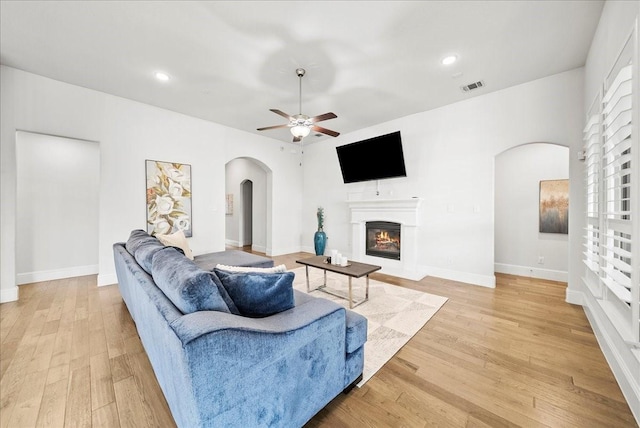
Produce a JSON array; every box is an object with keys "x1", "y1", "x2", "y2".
[{"x1": 113, "y1": 231, "x2": 367, "y2": 428}]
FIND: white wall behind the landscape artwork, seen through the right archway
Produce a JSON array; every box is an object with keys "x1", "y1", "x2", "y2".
[{"x1": 495, "y1": 143, "x2": 573, "y2": 281}]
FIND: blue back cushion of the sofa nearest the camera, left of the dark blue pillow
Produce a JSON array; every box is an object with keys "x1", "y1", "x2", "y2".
[{"x1": 151, "y1": 247, "x2": 230, "y2": 314}]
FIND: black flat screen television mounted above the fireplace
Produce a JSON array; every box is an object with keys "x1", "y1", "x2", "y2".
[{"x1": 336, "y1": 131, "x2": 407, "y2": 183}]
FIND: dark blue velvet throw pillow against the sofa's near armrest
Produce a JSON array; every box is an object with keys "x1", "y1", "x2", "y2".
[{"x1": 214, "y1": 269, "x2": 295, "y2": 318}]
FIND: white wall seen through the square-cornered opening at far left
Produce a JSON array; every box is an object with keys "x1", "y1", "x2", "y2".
[{"x1": 16, "y1": 132, "x2": 100, "y2": 284}]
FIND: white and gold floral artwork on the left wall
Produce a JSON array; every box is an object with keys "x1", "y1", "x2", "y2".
[{"x1": 146, "y1": 160, "x2": 192, "y2": 237}]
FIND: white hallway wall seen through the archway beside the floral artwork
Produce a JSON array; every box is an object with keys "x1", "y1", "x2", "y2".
[{"x1": 226, "y1": 158, "x2": 268, "y2": 253}]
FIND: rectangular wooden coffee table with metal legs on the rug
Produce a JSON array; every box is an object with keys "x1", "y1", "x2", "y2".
[{"x1": 296, "y1": 256, "x2": 382, "y2": 309}]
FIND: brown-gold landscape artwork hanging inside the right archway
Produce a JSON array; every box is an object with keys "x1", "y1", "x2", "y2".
[{"x1": 540, "y1": 180, "x2": 569, "y2": 234}]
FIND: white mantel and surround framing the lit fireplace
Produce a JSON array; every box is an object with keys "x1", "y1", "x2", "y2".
[{"x1": 347, "y1": 198, "x2": 426, "y2": 281}]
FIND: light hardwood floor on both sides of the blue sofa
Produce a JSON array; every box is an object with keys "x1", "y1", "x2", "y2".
[{"x1": 0, "y1": 253, "x2": 637, "y2": 428}]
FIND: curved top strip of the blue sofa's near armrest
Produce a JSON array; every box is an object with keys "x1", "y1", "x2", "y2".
[{"x1": 171, "y1": 298, "x2": 344, "y2": 346}]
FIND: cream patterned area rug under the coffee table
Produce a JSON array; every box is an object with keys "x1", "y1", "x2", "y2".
[{"x1": 292, "y1": 267, "x2": 447, "y2": 387}]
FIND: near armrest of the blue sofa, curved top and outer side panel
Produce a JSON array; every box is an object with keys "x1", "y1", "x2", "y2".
[{"x1": 170, "y1": 290, "x2": 346, "y2": 426}]
